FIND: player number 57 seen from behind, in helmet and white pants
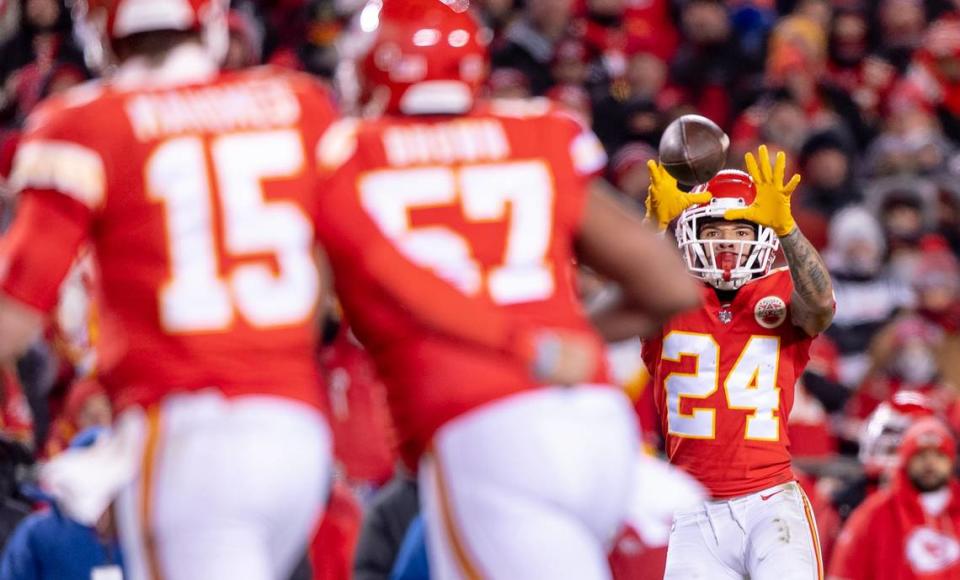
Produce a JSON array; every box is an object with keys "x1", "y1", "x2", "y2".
[{"x1": 320, "y1": 0, "x2": 699, "y2": 579}]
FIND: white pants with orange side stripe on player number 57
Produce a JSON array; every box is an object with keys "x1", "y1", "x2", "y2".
[{"x1": 418, "y1": 386, "x2": 640, "y2": 580}]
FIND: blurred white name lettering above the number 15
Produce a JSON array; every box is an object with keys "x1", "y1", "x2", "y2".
[{"x1": 126, "y1": 80, "x2": 300, "y2": 141}]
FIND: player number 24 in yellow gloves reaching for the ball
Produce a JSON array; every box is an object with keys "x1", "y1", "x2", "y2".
[{"x1": 643, "y1": 146, "x2": 834, "y2": 580}]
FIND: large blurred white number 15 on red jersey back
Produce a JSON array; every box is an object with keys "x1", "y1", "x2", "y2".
[{"x1": 146, "y1": 130, "x2": 320, "y2": 334}]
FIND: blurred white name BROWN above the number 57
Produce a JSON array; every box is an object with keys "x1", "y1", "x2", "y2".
[{"x1": 383, "y1": 119, "x2": 510, "y2": 167}]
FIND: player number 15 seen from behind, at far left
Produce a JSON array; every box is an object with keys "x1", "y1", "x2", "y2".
[{"x1": 0, "y1": 0, "x2": 592, "y2": 580}]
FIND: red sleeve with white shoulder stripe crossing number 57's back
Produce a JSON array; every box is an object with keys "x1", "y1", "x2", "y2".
[{"x1": 317, "y1": 126, "x2": 533, "y2": 361}]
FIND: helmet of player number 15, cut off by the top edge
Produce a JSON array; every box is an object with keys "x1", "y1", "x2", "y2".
[{"x1": 73, "y1": 0, "x2": 229, "y2": 69}]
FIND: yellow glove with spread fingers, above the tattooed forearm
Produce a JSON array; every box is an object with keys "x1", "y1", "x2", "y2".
[{"x1": 723, "y1": 145, "x2": 800, "y2": 238}]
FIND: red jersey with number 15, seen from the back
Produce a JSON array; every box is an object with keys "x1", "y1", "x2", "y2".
[{"x1": 0, "y1": 63, "x2": 334, "y2": 410}]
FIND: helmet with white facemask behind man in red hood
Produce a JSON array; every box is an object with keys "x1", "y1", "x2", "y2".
[{"x1": 859, "y1": 391, "x2": 937, "y2": 475}]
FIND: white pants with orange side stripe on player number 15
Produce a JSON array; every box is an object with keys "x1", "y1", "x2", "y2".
[{"x1": 116, "y1": 391, "x2": 332, "y2": 580}]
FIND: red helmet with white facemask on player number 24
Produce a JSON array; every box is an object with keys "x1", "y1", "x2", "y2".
[{"x1": 676, "y1": 169, "x2": 780, "y2": 290}]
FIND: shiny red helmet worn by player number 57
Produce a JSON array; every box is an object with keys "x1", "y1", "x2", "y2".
[{"x1": 346, "y1": 0, "x2": 490, "y2": 115}]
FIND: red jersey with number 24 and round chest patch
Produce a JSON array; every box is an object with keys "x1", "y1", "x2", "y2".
[{"x1": 643, "y1": 268, "x2": 812, "y2": 498}]
